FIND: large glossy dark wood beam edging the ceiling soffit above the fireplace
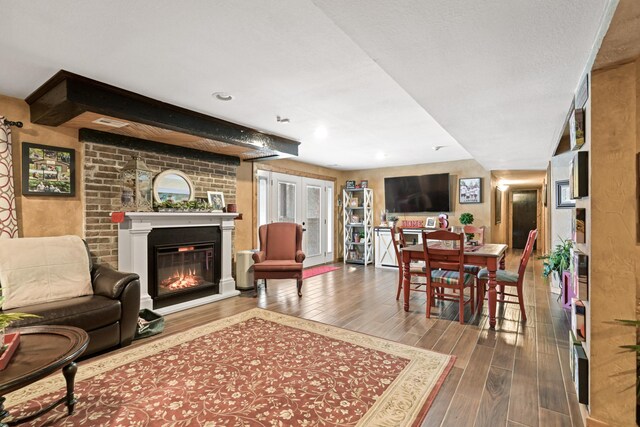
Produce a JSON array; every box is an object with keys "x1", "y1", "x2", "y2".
[{"x1": 25, "y1": 70, "x2": 300, "y2": 156}]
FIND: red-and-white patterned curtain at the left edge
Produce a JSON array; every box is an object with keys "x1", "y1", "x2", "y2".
[{"x1": 0, "y1": 116, "x2": 18, "y2": 239}]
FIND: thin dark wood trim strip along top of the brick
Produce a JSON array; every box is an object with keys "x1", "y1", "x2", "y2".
[{"x1": 78, "y1": 128, "x2": 240, "y2": 166}]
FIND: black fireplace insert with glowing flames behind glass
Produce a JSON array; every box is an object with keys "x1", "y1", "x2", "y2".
[{"x1": 149, "y1": 227, "x2": 220, "y2": 308}]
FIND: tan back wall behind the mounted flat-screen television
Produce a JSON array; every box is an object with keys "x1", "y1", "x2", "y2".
[{"x1": 343, "y1": 160, "x2": 493, "y2": 241}]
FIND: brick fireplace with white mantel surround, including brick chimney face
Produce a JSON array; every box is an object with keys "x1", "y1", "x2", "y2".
[{"x1": 82, "y1": 139, "x2": 239, "y2": 314}]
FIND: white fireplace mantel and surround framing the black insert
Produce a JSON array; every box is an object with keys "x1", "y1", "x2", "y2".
[{"x1": 118, "y1": 212, "x2": 240, "y2": 315}]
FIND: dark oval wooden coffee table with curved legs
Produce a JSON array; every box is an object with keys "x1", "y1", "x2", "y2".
[{"x1": 0, "y1": 326, "x2": 89, "y2": 427}]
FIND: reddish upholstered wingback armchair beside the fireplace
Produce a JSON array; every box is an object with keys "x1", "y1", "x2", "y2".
[{"x1": 253, "y1": 222, "x2": 305, "y2": 297}]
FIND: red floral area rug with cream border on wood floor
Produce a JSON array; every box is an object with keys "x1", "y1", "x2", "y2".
[{"x1": 6, "y1": 309, "x2": 454, "y2": 427}]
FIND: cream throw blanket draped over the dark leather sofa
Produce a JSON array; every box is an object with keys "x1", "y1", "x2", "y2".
[{"x1": 0, "y1": 236, "x2": 93, "y2": 310}]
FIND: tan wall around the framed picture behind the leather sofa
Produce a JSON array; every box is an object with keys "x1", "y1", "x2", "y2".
[{"x1": 0, "y1": 95, "x2": 84, "y2": 237}]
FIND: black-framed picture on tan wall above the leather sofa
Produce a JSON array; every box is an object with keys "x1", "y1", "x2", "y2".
[{"x1": 22, "y1": 142, "x2": 76, "y2": 197}]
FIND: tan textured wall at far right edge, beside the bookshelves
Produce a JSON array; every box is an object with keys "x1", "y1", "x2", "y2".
[{"x1": 580, "y1": 60, "x2": 640, "y2": 426}]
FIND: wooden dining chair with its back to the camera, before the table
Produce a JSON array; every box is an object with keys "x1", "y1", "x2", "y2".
[{"x1": 422, "y1": 230, "x2": 476, "y2": 324}]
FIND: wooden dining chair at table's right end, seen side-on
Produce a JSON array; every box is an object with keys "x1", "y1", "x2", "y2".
[{"x1": 478, "y1": 230, "x2": 538, "y2": 322}]
